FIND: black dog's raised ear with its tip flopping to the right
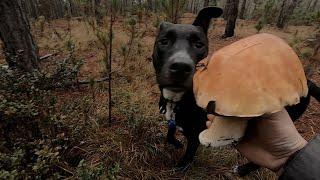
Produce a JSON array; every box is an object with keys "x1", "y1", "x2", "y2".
[{"x1": 192, "y1": 7, "x2": 223, "y2": 34}]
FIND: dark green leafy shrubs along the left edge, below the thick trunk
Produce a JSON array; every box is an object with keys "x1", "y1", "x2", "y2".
[{"x1": 0, "y1": 42, "x2": 82, "y2": 179}]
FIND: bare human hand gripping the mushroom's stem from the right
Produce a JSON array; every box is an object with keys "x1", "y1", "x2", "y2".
[{"x1": 235, "y1": 110, "x2": 307, "y2": 171}]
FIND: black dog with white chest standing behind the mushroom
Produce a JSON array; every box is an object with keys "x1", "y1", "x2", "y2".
[{"x1": 153, "y1": 7, "x2": 320, "y2": 174}]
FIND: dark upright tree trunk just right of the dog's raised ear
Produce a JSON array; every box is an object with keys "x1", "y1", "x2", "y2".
[{"x1": 223, "y1": 0, "x2": 239, "y2": 38}]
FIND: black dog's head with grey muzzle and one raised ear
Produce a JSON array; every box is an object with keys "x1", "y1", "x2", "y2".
[{"x1": 153, "y1": 7, "x2": 223, "y2": 92}]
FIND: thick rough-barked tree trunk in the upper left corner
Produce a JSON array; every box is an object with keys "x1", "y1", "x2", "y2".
[{"x1": 0, "y1": 0, "x2": 39, "y2": 71}]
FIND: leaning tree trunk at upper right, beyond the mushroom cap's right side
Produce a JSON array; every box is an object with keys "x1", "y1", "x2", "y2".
[{"x1": 277, "y1": 0, "x2": 301, "y2": 29}]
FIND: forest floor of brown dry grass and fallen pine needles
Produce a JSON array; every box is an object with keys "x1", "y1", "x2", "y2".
[{"x1": 0, "y1": 14, "x2": 320, "y2": 179}]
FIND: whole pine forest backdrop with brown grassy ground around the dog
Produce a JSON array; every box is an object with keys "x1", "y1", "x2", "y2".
[{"x1": 0, "y1": 0, "x2": 320, "y2": 179}]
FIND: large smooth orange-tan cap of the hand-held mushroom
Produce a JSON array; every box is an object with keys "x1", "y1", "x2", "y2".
[{"x1": 193, "y1": 34, "x2": 308, "y2": 117}]
